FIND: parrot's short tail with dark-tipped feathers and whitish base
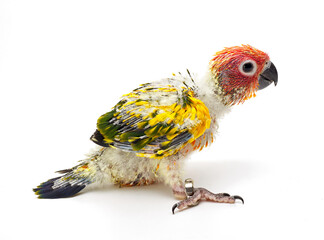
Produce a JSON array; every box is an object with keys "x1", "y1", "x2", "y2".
[{"x1": 33, "y1": 148, "x2": 105, "y2": 198}]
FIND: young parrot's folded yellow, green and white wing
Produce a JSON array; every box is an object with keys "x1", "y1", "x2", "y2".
[{"x1": 91, "y1": 79, "x2": 210, "y2": 158}]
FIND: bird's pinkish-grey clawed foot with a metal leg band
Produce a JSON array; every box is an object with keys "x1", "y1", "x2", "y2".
[{"x1": 172, "y1": 179, "x2": 244, "y2": 214}]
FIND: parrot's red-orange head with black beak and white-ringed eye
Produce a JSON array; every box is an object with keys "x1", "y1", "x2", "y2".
[{"x1": 209, "y1": 45, "x2": 278, "y2": 105}]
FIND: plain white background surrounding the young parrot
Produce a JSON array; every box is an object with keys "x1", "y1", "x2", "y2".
[{"x1": 0, "y1": 0, "x2": 324, "y2": 240}]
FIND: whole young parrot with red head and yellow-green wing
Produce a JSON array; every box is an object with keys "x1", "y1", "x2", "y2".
[{"x1": 33, "y1": 45, "x2": 278, "y2": 212}]
